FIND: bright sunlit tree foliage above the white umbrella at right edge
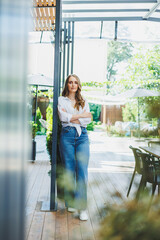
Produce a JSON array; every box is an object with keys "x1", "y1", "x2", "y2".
[{"x1": 116, "y1": 45, "x2": 160, "y2": 90}]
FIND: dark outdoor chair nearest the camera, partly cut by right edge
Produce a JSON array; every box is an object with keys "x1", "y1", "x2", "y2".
[{"x1": 136, "y1": 152, "x2": 160, "y2": 198}]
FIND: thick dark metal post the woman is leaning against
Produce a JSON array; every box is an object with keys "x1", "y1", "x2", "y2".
[{"x1": 50, "y1": 0, "x2": 61, "y2": 211}]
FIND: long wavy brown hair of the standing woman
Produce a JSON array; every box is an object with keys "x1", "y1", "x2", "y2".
[{"x1": 62, "y1": 74, "x2": 85, "y2": 111}]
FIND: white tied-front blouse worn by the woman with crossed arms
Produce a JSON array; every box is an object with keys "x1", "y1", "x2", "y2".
[{"x1": 58, "y1": 96, "x2": 91, "y2": 136}]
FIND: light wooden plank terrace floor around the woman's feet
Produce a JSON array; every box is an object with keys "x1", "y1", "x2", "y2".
[{"x1": 26, "y1": 132, "x2": 149, "y2": 240}]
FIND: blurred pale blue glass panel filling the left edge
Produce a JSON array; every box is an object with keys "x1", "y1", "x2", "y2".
[{"x1": 0, "y1": 0, "x2": 30, "y2": 240}]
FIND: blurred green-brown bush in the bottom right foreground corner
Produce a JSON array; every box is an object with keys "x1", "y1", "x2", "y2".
[{"x1": 98, "y1": 195, "x2": 160, "y2": 240}]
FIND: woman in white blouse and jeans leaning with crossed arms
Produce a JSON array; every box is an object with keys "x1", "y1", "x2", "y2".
[{"x1": 58, "y1": 74, "x2": 91, "y2": 220}]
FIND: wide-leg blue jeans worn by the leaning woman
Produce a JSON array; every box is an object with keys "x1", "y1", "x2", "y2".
[{"x1": 59, "y1": 126, "x2": 89, "y2": 210}]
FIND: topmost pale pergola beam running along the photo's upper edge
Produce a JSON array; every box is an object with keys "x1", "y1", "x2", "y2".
[{"x1": 62, "y1": 0, "x2": 157, "y2": 4}]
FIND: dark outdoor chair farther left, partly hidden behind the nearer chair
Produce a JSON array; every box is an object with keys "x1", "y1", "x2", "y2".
[{"x1": 127, "y1": 146, "x2": 143, "y2": 197}]
